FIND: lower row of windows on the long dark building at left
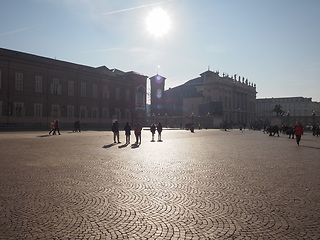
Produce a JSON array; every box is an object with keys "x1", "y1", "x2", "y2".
[{"x1": 6, "y1": 102, "x2": 131, "y2": 119}]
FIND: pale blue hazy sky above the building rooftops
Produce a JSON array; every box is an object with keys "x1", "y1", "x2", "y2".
[{"x1": 0, "y1": 0, "x2": 320, "y2": 101}]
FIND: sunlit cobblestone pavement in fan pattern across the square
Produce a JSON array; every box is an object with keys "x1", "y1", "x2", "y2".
[{"x1": 0, "y1": 130, "x2": 320, "y2": 239}]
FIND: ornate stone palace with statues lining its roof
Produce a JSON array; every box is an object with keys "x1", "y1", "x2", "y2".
[{"x1": 165, "y1": 70, "x2": 257, "y2": 127}]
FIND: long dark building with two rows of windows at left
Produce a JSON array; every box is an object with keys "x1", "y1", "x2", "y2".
[{"x1": 0, "y1": 48, "x2": 148, "y2": 128}]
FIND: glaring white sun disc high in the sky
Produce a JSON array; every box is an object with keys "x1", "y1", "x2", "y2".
[{"x1": 146, "y1": 8, "x2": 171, "y2": 37}]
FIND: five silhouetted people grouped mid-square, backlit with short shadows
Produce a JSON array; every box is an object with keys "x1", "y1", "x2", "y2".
[{"x1": 112, "y1": 121, "x2": 162, "y2": 145}]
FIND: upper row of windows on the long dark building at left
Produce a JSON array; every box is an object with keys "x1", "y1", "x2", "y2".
[{"x1": 0, "y1": 70, "x2": 130, "y2": 102}]
